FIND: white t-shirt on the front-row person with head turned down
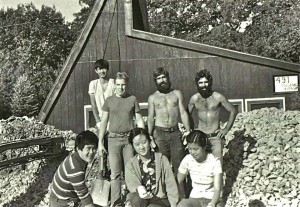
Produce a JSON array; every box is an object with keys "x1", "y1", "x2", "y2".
[{"x1": 178, "y1": 153, "x2": 222, "y2": 199}]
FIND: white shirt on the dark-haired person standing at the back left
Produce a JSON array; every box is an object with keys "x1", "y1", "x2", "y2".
[{"x1": 89, "y1": 79, "x2": 114, "y2": 119}]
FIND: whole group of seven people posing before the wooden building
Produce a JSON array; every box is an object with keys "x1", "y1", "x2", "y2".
[{"x1": 50, "y1": 59, "x2": 237, "y2": 207}]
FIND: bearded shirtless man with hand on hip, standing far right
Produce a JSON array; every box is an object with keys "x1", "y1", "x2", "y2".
[{"x1": 188, "y1": 69, "x2": 237, "y2": 163}]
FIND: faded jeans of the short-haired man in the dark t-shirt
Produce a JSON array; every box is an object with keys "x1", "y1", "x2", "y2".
[{"x1": 108, "y1": 134, "x2": 133, "y2": 206}]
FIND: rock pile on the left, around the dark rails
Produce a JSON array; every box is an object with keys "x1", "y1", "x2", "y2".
[{"x1": 0, "y1": 117, "x2": 76, "y2": 207}]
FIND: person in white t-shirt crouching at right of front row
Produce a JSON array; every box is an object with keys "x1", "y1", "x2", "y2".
[{"x1": 177, "y1": 130, "x2": 224, "y2": 207}]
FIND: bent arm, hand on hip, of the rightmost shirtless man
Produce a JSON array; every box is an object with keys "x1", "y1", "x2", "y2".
[{"x1": 218, "y1": 94, "x2": 237, "y2": 138}]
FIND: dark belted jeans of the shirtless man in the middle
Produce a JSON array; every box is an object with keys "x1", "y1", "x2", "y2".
[{"x1": 153, "y1": 129, "x2": 184, "y2": 175}]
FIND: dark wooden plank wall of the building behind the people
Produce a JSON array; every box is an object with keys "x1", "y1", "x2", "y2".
[{"x1": 46, "y1": 0, "x2": 300, "y2": 132}]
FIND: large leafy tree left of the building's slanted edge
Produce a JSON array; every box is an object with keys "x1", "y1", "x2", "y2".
[{"x1": 0, "y1": 3, "x2": 75, "y2": 117}]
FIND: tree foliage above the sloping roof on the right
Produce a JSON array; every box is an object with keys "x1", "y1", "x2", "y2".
[{"x1": 147, "y1": 0, "x2": 300, "y2": 63}]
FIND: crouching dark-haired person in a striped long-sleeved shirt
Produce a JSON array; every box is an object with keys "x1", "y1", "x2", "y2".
[{"x1": 49, "y1": 131, "x2": 98, "y2": 207}]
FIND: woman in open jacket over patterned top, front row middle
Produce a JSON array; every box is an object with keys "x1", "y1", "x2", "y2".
[{"x1": 125, "y1": 128, "x2": 179, "y2": 207}]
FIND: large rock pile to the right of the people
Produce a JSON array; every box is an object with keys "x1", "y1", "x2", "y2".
[{"x1": 224, "y1": 108, "x2": 300, "y2": 207}]
